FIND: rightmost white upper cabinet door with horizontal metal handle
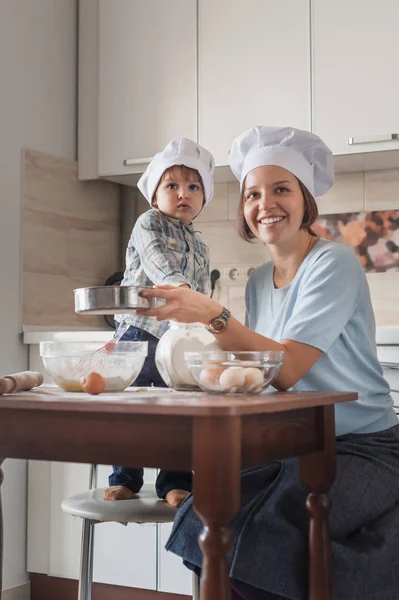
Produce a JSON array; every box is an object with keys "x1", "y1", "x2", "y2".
[{"x1": 312, "y1": 0, "x2": 399, "y2": 154}]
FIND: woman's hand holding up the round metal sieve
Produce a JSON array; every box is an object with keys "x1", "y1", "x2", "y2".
[{"x1": 136, "y1": 285, "x2": 223, "y2": 325}]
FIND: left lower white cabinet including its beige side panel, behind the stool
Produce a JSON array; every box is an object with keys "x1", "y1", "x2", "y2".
[{"x1": 27, "y1": 461, "x2": 158, "y2": 590}]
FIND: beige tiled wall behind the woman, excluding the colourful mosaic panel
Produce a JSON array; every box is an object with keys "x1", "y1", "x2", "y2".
[{"x1": 137, "y1": 169, "x2": 399, "y2": 325}]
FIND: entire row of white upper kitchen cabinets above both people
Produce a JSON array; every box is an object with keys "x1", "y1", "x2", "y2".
[{"x1": 78, "y1": 0, "x2": 399, "y2": 185}]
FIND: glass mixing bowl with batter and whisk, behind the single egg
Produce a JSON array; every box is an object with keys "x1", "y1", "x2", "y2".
[{"x1": 40, "y1": 342, "x2": 148, "y2": 392}]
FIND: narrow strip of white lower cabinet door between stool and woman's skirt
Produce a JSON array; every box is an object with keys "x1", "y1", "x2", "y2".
[{"x1": 158, "y1": 523, "x2": 192, "y2": 596}]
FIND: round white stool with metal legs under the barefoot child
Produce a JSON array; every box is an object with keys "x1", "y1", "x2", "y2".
[{"x1": 61, "y1": 465, "x2": 199, "y2": 600}]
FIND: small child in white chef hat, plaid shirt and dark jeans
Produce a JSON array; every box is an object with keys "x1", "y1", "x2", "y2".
[{"x1": 104, "y1": 138, "x2": 215, "y2": 507}]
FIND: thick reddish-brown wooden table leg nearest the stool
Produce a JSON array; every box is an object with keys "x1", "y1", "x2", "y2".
[{"x1": 193, "y1": 417, "x2": 241, "y2": 600}]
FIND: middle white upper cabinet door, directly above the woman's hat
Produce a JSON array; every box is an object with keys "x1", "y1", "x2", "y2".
[{"x1": 198, "y1": 0, "x2": 310, "y2": 165}]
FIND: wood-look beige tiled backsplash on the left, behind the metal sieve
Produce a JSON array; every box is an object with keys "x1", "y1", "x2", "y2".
[{"x1": 22, "y1": 150, "x2": 122, "y2": 328}]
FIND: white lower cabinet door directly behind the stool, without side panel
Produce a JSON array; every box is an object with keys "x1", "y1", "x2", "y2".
[{"x1": 46, "y1": 463, "x2": 157, "y2": 590}]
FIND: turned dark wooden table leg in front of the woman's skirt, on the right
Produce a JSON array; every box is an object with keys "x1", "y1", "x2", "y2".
[{"x1": 299, "y1": 406, "x2": 336, "y2": 600}]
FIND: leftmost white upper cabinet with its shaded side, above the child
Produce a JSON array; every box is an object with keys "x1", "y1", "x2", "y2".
[{"x1": 78, "y1": 0, "x2": 197, "y2": 179}]
